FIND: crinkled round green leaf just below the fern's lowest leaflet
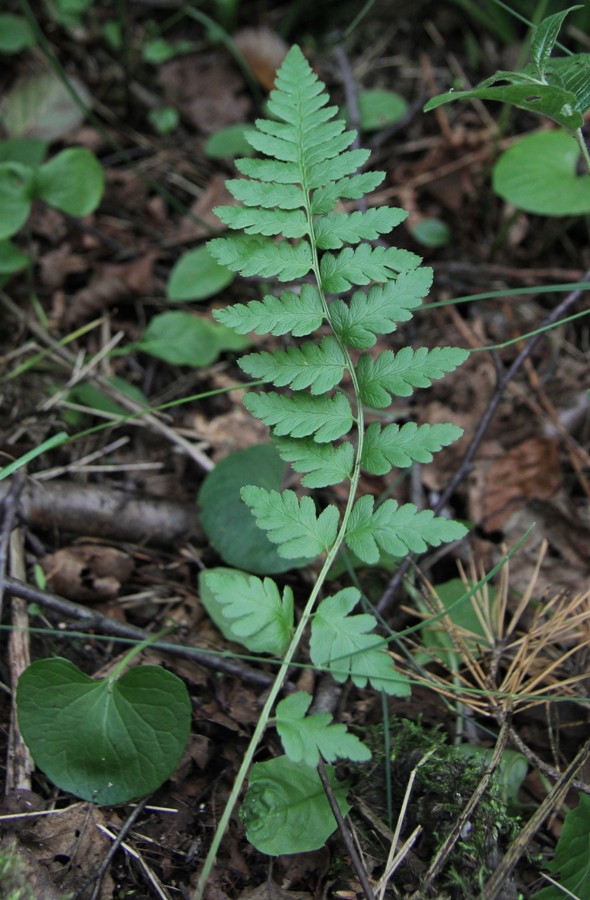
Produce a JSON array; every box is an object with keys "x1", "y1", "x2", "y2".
[{"x1": 240, "y1": 756, "x2": 350, "y2": 856}]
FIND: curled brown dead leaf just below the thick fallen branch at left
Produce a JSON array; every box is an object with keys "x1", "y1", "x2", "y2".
[{"x1": 41, "y1": 544, "x2": 134, "y2": 603}]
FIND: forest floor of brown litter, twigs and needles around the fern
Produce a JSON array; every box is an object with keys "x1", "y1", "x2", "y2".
[{"x1": 0, "y1": 0, "x2": 590, "y2": 900}]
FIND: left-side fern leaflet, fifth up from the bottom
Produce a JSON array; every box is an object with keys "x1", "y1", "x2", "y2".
[{"x1": 240, "y1": 335, "x2": 346, "y2": 394}]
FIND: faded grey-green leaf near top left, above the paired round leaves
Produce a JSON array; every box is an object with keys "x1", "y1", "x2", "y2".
[{"x1": 1, "y1": 71, "x2": 91, "y2": 141}]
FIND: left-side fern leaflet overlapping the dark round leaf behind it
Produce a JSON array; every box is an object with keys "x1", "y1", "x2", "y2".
[{"x1": 241, "y1": 485, "x2": 339, "y2": 559}]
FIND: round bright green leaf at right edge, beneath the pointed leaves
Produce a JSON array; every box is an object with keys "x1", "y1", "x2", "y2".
[{"x1": 493, "y1": 131, "x2": 590, "y2": 216}]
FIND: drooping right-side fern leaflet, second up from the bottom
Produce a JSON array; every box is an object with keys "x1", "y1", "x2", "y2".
[{"x1": 309, "y1": 588, "x2": 410, "y2": 697}]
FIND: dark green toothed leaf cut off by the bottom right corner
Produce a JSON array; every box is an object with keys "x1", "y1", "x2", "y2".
[{"x1": 533, "y1": 794, "x2": 590, "y2": 900}]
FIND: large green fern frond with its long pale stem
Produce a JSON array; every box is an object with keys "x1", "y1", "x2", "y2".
[{"x1": 200, "y1": 47, "x2": 467, "y2": 890}]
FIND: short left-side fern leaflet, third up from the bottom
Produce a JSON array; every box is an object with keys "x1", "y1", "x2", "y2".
[{"x1": 273, "y1": 437, "x2": 354, "y2": 488}]
